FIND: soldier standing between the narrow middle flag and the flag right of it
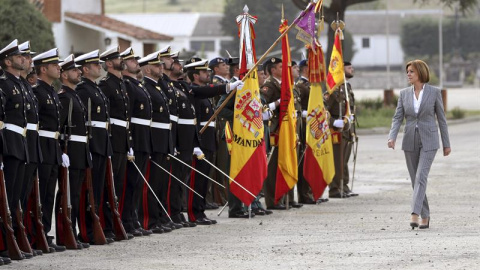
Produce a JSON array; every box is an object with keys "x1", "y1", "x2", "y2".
[{"x1": 292, "y1": 59, "x2": 316, "y2": 204}]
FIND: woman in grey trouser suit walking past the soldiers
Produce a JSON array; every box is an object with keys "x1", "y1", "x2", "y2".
[{"x1": 388, "y1": 60, "x2": 451, "y2": 229}]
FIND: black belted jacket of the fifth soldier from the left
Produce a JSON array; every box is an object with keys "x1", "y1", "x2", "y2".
[{"x1": 75, "y1": 77, "x2": 113, "y2": 156}]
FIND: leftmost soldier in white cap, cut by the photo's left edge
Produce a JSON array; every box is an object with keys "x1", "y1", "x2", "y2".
[{"x1": 0, "y1": 40, "x2": 33, "y2": 262}]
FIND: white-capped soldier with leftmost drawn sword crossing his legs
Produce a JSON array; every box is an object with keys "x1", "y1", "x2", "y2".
[{"x1": 138, "y1": 52, "x2": 173, "y2": 233}]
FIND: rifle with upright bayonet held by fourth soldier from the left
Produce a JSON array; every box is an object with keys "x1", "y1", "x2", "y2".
[{"x1": 55, "y1": 99, "x2": 78, "y2": 249}]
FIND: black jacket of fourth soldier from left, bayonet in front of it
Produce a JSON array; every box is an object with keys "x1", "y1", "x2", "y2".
[{"x1": 58, "y1": 85, "x2": 92, "y2": 169}]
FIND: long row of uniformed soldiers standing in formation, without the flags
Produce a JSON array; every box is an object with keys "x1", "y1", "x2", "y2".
[{"x1": 0, "y1": 35, "x2": 358, "y2": 263}]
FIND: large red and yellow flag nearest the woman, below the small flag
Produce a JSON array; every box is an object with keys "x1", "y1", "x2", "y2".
[{"x1": 303, "y1": 46, "x2": 334, "y2": 200}]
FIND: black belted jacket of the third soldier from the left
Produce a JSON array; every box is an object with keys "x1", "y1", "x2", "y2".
[{"x1": 33, "y1": 79, "x2": 62, "y2": 165}]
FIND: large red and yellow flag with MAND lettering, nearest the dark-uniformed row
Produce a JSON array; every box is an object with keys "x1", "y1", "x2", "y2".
[{"x1": 230, "y1": 8, "x2": 267, "y2": 206}]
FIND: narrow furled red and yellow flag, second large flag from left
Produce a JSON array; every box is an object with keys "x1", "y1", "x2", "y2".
[{"x1": 275, "y1": 20, "x2": 298, "y2": 203}]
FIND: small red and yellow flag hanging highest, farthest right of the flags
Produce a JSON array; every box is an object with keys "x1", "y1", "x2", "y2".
[{"x1": 327, "y1": 29, "x2": 345, "y2": 94}]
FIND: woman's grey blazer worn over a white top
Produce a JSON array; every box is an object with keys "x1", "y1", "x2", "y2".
[{"x1": 388, "y1": 84, "x2": 450, "y2": 151}]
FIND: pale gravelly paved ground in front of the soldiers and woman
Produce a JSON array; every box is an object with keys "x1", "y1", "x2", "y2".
[{"x1": 3, "y1": 119, "x2": 480, "y2": 270}]
